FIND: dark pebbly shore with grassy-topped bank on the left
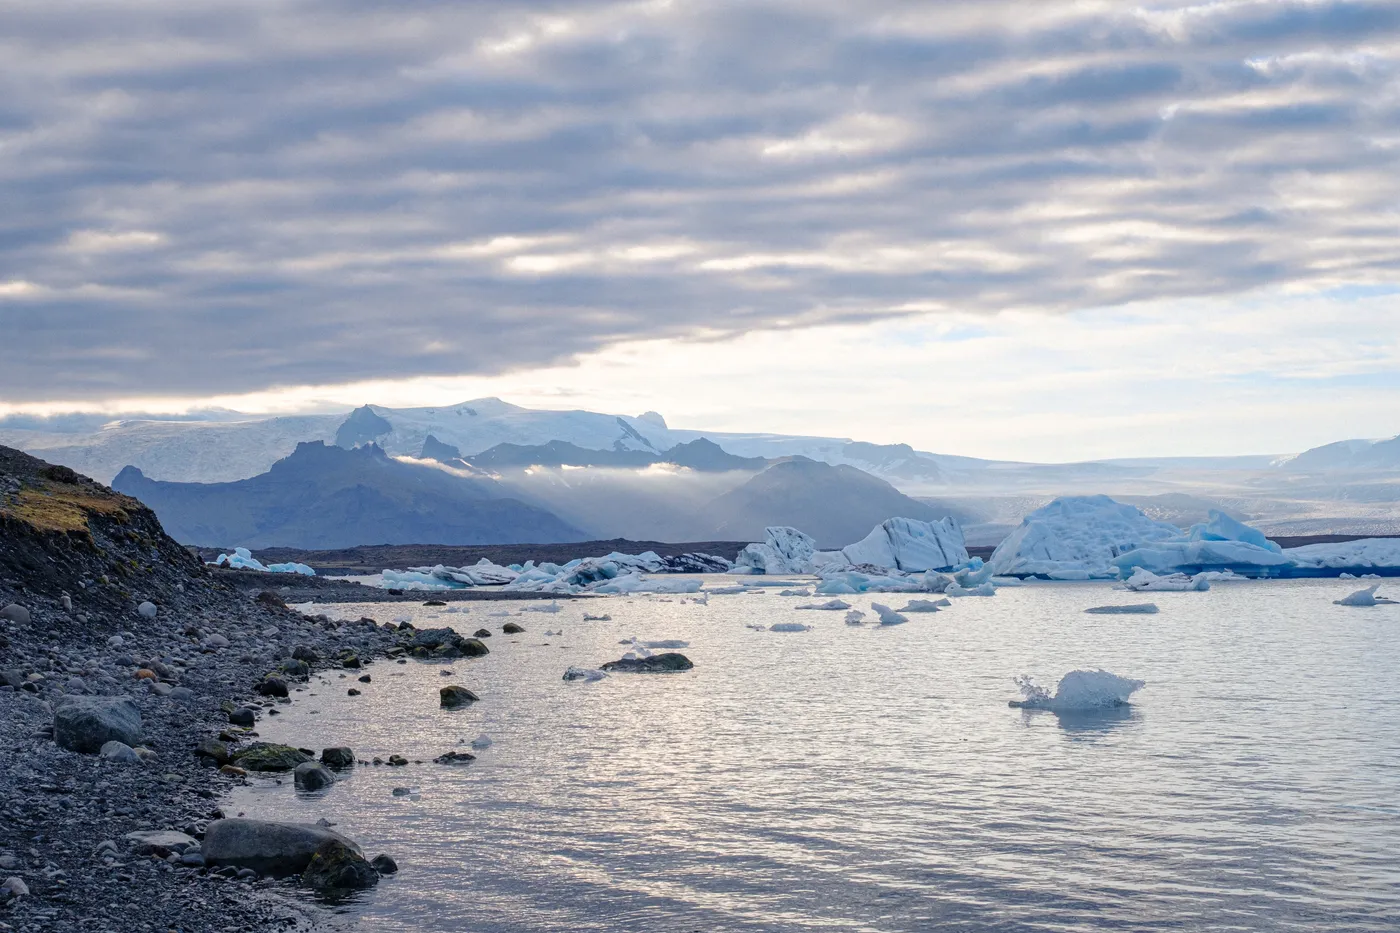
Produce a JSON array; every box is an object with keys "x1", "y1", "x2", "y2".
[{"x1": 0, "y1": 448, "x2": 412, "y2": 933}]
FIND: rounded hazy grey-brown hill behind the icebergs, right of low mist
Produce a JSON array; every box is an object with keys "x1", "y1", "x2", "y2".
[{"x1": 692, "y1": 457, "x2": 942, "y2": 548}]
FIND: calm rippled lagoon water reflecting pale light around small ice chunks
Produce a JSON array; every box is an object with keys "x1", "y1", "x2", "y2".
[{"x1": 232, "y1": 581, "x2": 1400, "y2": 932}]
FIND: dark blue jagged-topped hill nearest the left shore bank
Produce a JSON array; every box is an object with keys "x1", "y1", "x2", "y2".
[{"x1": 112, "y1": 441, "x2": 594, "y2": 548}]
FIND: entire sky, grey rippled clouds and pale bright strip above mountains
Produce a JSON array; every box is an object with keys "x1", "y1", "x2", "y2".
[{"x1": 0, "y1": 0, "x2": 1400, "y2": 459}]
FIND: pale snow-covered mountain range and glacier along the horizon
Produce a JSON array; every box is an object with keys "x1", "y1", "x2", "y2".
[{"x1": 8, "y1": 398, "x2": 1400, "y2": 545}]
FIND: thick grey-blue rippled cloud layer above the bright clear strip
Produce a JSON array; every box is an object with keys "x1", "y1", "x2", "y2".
[{"x1": 0, "y1": 0, "x2": 1400, "y2": 402}]
